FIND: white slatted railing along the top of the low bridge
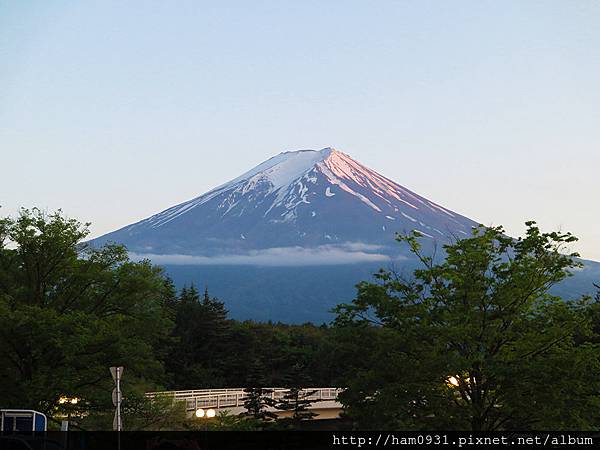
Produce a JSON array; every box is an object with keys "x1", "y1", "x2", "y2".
[{"x1": 146, "y1": 388, "x2": 342, "y2": 411}]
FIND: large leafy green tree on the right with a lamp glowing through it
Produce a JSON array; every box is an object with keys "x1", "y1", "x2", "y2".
[{"x1": 337, "y1": 222, "x2": 600, "y2": 430}]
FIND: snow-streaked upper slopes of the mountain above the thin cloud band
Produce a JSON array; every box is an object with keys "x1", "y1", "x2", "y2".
[{"x1": 95, "y1": 148, "x2": 476, "y2": 264}]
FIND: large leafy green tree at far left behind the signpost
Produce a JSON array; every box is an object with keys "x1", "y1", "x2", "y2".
[{"x1": 0, "y1": 209, "x2": 172, "y2": 420}]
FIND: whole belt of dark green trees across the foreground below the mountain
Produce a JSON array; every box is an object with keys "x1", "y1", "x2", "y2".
[{"x1": 0, "y1": 209, "x2": 600, "y2": 430}]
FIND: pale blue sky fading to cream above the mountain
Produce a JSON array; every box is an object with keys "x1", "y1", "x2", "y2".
[{"x1": 0, "y1": 0, "x2": 600, "y2": 260}]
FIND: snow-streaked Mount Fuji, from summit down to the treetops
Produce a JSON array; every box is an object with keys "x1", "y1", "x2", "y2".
[{"x1": 91, "y1": 148, "x2": 596, "y2": 322}]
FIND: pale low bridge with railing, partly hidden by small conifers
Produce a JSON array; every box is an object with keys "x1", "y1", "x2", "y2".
[{"x1": 146, "y1": 387, "x2": 342, "y2": 420}]
